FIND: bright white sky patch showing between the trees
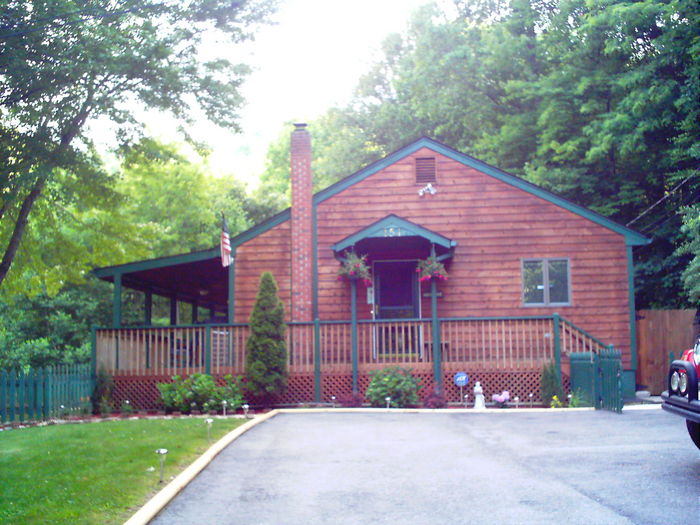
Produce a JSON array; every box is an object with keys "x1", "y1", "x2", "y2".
[{"x1": 186, "y1": 0, "x2": 452, "y2": 185}]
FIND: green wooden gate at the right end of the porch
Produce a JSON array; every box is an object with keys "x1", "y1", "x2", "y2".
[{"x1": 569, "y1": 348, "x2": 624, "y2": 413}]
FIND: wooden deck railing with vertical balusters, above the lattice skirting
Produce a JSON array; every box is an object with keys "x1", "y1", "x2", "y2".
[{"x1": 95, "y1": 315, "x2": 607, "y2": 376}]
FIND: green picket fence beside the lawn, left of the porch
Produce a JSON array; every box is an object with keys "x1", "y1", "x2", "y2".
[{"x1": 0, "y1": 364, "x2": 93, "y2": 423}]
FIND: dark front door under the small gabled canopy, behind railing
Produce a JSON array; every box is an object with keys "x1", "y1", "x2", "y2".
[{"x1": 374, "y1": 261, "x2": 422, "y2": 361}]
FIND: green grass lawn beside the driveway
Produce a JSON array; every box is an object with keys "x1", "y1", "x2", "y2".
[{"x1": 0, "y1": 418, "x2": 244, "y2": 524}]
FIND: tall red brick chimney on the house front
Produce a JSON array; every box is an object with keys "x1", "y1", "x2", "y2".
[{"x1": 291, "y1": 124, "x2": 313, "y2": 321}]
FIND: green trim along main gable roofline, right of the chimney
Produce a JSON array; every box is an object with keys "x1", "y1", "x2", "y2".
[{"x1": 314, "y1": 137, "x2": 651, "y2": 246}]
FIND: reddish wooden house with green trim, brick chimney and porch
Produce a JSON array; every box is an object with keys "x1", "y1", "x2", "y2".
[{"x1": 94, "y1": 124, "x2": 648, "y2": 405}]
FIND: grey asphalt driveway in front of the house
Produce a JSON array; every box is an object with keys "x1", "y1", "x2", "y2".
[{"x1": 153, "y1": 408, "x2": 700, "y2": 525}]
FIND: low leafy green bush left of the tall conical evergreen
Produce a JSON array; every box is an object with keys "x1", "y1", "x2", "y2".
[{"x1": 156, "y1": 373, "x2": 243, "y2": 413}]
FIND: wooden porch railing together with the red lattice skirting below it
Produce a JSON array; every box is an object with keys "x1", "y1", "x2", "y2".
[{"x1": 94, "y1": 314, "x2": 607, "y2": 407}]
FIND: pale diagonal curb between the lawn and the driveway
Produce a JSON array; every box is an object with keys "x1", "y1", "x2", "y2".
[{"x1": 124, "y1": 410, "x2": 279, "y2": 525}]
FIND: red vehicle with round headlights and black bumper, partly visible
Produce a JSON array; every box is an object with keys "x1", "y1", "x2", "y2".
[{"x1": 662, "y1": 337, "x2": 700, "y2": 448}]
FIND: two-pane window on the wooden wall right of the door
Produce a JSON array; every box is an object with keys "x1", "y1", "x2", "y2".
[{"x1": 523, "y1": 259, "x2": 571, "y2": 306}]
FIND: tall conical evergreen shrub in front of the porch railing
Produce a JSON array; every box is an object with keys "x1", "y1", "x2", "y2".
[{"x1": 246, "y1": 272, "x2": 287, "y2": 398}]
